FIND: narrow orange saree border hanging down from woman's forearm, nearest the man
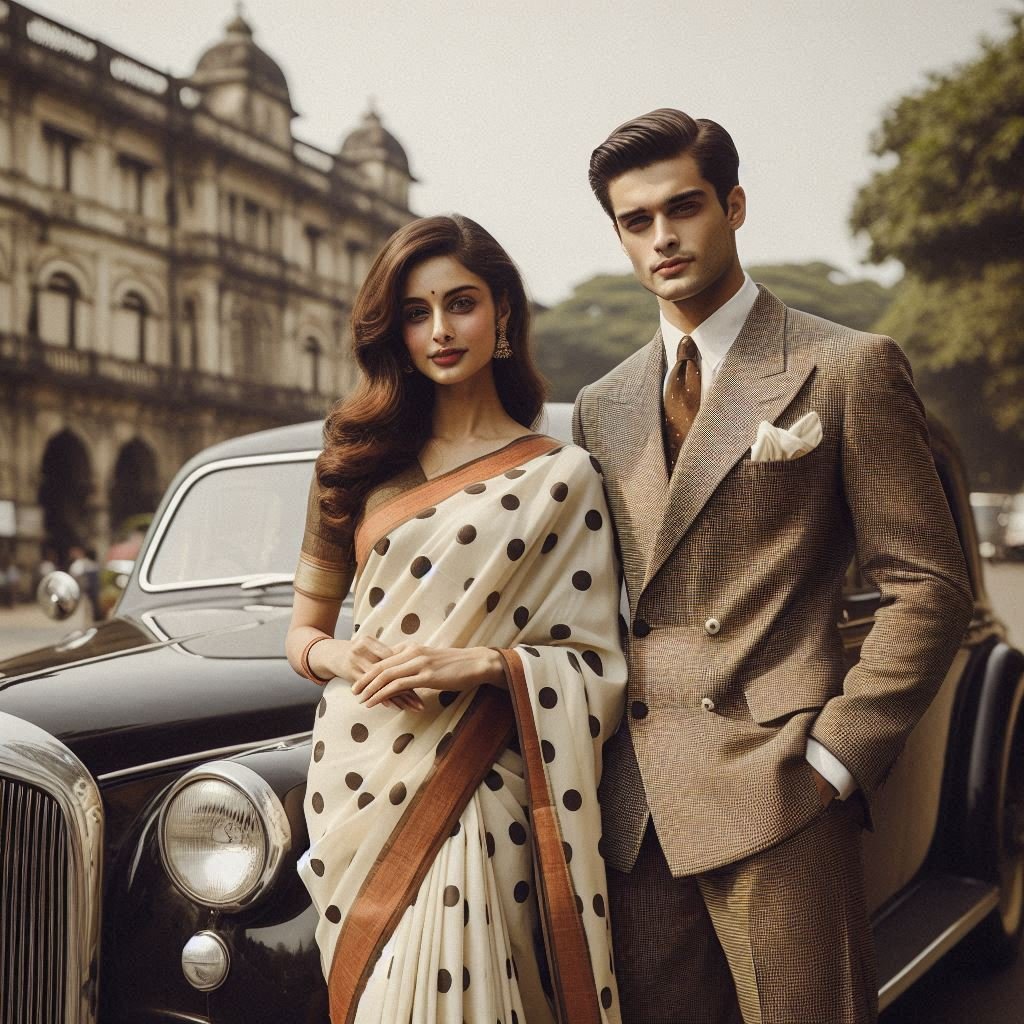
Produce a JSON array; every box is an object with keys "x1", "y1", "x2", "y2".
[{"x1": 499, "y1": 649, "x2": 601, "y2": 1024}]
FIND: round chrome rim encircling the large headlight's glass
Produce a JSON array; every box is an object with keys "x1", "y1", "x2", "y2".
[{"x1": 157, "y1": 761, "x2": 292, "y2": 912}]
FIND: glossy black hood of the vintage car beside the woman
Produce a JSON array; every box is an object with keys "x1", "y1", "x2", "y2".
[{"x1": 0, "y1": 605, "x2": 319, "y2": 775}]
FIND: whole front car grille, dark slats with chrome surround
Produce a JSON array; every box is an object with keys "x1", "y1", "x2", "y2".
[{"x1": 0, "y1": 712, "x2": 103, "y2": 1024}]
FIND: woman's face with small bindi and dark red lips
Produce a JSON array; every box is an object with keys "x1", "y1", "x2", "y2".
[{"x1": 400, "y1": 256, "x2": 508, "y2": 385}]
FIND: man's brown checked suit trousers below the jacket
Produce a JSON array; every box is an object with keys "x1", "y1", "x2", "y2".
[{"x1": 608, "y1": 801, "x2": 878, "y2": 1024}]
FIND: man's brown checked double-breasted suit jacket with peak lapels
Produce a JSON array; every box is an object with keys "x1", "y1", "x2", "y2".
[{"x1": 573, "y1": 288, "x2": 972, "y2": 877}]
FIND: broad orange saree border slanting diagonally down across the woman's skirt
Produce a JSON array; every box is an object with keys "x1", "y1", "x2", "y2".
[{"x1": 328, "y1": 686, "x2": 514, "y2": 1024}]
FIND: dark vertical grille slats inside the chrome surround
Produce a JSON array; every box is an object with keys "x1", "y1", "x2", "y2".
[{"x1": 0, "y1": 778, "x2": 71, "y2": 1024}]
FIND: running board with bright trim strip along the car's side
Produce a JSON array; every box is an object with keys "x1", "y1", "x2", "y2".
[{"x1": 871, "y1": 874, "x2": 999, "y2": 1010}]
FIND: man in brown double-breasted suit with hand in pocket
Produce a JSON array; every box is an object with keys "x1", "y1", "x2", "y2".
[{"x1": 573, "y1": 110, "x2": 972, "y2": 1024}]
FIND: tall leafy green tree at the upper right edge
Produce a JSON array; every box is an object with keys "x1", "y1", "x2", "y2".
[{"x1": 850, "y1": 11, "x2": 1024, "y2": 486}]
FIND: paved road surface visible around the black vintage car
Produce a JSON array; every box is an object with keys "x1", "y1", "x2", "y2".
[{"x1": 0, "y1": 564, "x2": 1024, "y2": 1024}]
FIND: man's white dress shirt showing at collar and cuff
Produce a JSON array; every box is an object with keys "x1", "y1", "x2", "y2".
[{"x1": 662, "y1": 273, "x2": 857, "y2": 800}]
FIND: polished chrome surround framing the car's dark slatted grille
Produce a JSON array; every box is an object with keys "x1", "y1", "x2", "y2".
[{"x1": 0, "y1": 712, "x2": 103, "y2": 1024}]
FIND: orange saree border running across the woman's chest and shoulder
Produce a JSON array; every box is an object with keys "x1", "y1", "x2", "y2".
[{"x1": 355, "y1": 434, "x2": 565, "y2": 572}]
